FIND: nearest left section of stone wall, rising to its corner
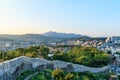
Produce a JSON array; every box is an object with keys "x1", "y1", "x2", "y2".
[{"x1": 0, "y1": 56, "x2": 32, "y2": 80}]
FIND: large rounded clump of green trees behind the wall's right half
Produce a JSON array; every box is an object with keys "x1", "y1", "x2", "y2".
[{"x1": 53, "y1": 47, "x2": 109, "y2": 67}]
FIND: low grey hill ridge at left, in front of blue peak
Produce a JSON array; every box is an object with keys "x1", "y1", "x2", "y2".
[{"x1": 0, "y1": 34, "x2": 62, "y2": 42}]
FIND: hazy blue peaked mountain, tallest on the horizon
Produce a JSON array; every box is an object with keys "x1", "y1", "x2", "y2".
[{"x1": 41, "y1": 31, "x2": 82, "y2": 38}]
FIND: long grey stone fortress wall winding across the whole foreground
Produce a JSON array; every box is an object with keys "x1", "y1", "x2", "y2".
[{"x1": 0, "y1": 56, "x2": 109, "y2": 80}]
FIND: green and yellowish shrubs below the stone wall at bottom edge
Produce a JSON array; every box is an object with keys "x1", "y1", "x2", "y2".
[{"x1": 30, "y1": 69, "x2": 110, "y2": 80}]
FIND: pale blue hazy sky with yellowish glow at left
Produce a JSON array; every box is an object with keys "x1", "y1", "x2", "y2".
[{"x1": 0, "y1": 0, "x2": 120, "y2": 36}]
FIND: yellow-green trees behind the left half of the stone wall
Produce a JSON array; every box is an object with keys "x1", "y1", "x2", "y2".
[{"x1": 0, "y1": 46, "x2": 49, "y2": 62}]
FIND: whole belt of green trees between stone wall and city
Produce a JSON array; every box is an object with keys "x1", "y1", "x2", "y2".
[{"x1": 0, "y1": 46, "x2": 109, "y2": 67}]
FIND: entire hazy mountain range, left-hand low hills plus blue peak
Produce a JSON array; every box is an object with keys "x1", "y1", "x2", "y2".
[{"x1": 0, "y1": 31, "x2": 88, "y2": 43}]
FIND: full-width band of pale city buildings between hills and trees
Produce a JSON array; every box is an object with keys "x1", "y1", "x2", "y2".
[{"x1": 0, "y1": 36, "x2": 120, "y2": 53}]
